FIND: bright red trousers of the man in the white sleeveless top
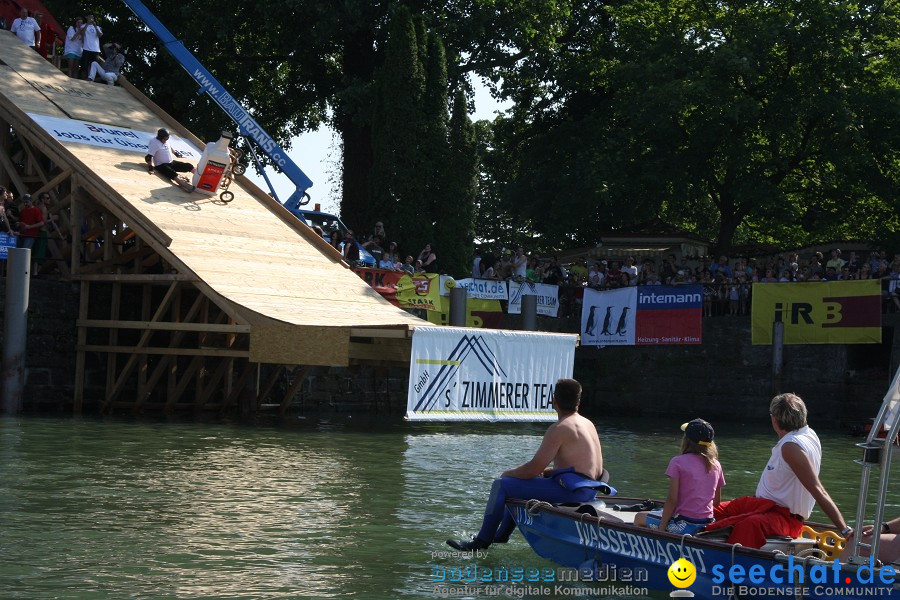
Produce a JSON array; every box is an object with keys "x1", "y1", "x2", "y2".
[{"x1": 706, "y1": 496, "x2": 803, "y2": 548}]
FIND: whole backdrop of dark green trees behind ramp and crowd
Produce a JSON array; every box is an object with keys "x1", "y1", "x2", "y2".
[{"x1": 45, "y1": 0, "x2": 900, "y2": 261}]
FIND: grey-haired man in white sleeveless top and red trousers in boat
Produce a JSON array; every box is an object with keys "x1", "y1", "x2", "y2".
[{"x1": 707, "y1": 394, "x2": 853, "y2": 548}]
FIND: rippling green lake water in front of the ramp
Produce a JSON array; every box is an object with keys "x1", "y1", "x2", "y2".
[{"x1": 0, "y1": 414, "x2": 900, "y2": 599}]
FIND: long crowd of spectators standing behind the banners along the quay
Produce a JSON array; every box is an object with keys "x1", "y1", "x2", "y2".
[{"x1": 314, "y1": 221, "x2": 900, "y2": 316}]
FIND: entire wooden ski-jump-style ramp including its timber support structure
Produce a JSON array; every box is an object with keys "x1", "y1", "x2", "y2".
[{"x1": 0, "y1": 32, "x2": 426, "y2": 408}]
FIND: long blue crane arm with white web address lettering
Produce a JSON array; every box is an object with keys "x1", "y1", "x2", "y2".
[{"x1": 122, "y1": 0, "x2": 312, "y2": 208}]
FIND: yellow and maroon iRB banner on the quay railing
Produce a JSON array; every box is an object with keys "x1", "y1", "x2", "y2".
[{"x1": 751, "y1": 279, "x2": 881, "y2": 344}]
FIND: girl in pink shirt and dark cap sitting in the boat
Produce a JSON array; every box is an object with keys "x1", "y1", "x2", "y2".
[{"x1": 634, "y1": 419, "x2": 725, "y2": 534}]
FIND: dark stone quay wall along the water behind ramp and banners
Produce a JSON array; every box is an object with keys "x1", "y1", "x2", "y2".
[{"x1": 0, "y1": 279, "x2": 900, "y2": 424}]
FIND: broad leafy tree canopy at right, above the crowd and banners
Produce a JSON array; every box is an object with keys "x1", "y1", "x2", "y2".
[{"x1": 482, "y1": 0, "x2": 900, "y2": 249}]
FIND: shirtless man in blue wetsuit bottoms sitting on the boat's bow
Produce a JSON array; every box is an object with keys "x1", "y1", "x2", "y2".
[{"x1": 447, "y1": 379, "x2": 603, "y2": 551}]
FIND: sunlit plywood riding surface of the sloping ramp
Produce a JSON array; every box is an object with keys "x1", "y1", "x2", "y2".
[{"x1": 0, "y1": 32, "x2": 427, "y2": 327}]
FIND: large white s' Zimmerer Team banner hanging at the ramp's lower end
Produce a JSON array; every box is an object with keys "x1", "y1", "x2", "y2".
[{"x1": 406, "y1": 327, "x2": 577, "y2": 421}]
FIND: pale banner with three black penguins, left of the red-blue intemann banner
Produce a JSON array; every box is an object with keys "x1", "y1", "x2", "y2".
[{"x1": 581, "y1": 287, "x2": 637, "y2": 346}]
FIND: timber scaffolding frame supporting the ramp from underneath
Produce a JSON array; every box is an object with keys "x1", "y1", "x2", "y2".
[{"x1": 0, "y1": 40, "x2": 415, "y2": 414}]
